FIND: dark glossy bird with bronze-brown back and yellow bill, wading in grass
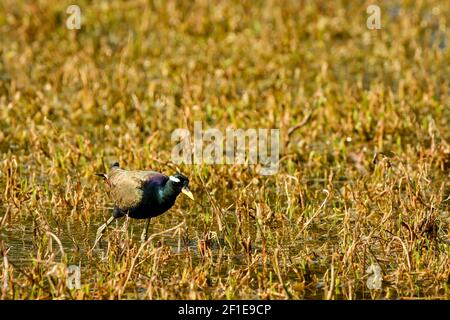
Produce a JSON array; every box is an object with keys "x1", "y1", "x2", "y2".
[{"x1": 93, "y1": 162, "x2": 194, "y2": 247}]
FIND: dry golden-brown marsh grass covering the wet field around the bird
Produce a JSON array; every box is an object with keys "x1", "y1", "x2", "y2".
[{"x1": 0, "y1": 0, "x2": 450, "y2": 299}]
